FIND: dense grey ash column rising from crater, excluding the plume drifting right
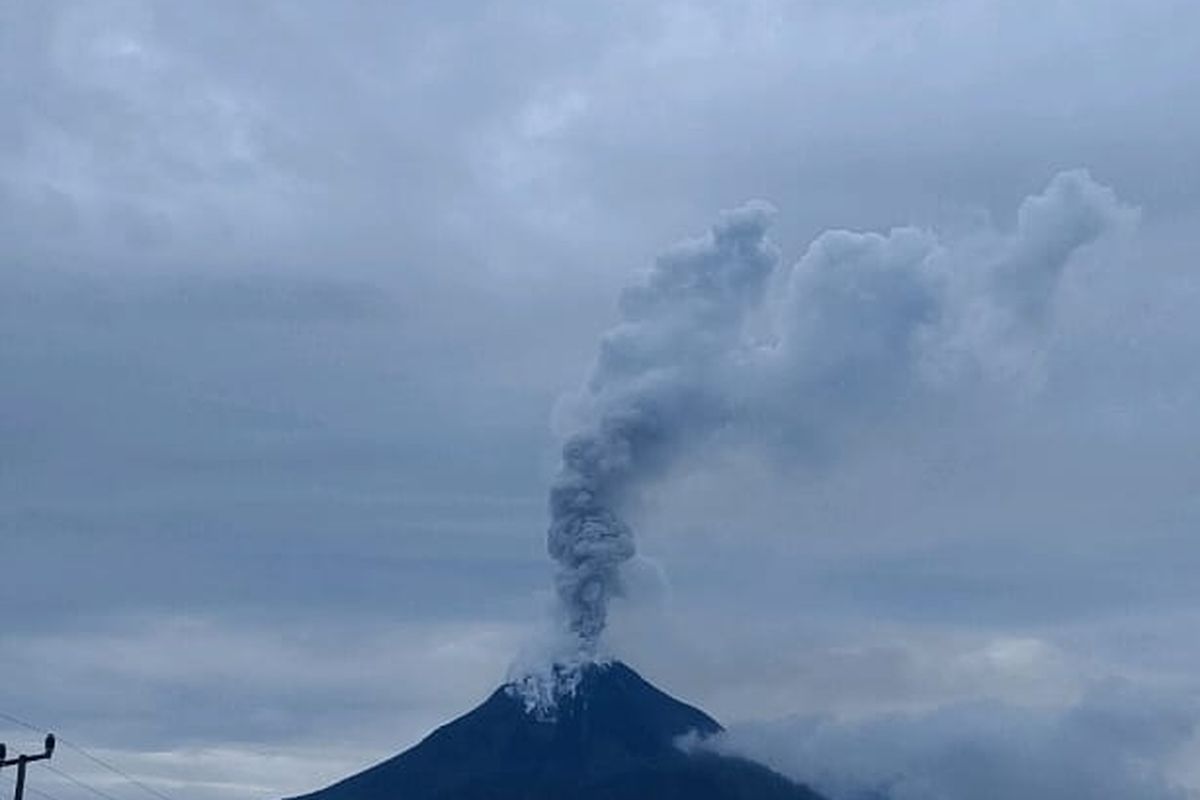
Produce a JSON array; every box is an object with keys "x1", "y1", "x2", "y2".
[{"x1": 547, "y1": 203, "x2": 779, "y2": 651}]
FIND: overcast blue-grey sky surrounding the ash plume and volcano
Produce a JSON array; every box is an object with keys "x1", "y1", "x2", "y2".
[{"x1": 0, "y1": 0, "x2": 1200, "y2": 800}]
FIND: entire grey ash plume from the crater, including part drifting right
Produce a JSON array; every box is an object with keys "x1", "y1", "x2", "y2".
[{"x1": 548, "y1": 170, "x2": 1133, "y2": 652}]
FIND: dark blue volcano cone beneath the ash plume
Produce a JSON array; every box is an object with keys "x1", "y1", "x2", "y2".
[{"x1": 293, "y1": 662, "x2": 824, "y2": 800}]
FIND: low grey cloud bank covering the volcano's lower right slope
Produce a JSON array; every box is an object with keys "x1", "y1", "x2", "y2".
[{"x1": 709, "y1": 682, "x2": 1200, "y2": 800}]
